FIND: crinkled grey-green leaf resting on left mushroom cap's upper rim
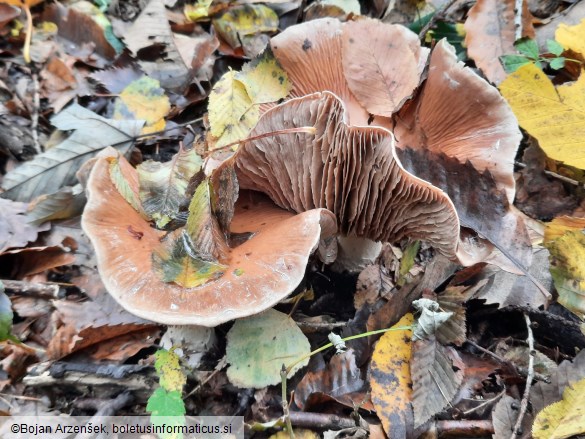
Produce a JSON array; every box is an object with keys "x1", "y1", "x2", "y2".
[{"x1": 136, "y1": 148, "x2": 203, "y2": 228}]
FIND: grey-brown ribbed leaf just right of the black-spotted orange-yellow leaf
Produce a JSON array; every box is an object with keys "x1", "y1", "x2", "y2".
[{"x1": 410, "y1": 337, "x2": 464, "y2": 427}]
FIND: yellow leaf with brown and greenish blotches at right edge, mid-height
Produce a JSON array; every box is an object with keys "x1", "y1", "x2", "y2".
[{"x1": 546, "y1": 230, "x2": 585, "y2": 317}]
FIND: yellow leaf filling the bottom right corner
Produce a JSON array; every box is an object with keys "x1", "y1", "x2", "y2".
[{"x1": 532, "y1": 379, "x2": 585, "y2": 439}]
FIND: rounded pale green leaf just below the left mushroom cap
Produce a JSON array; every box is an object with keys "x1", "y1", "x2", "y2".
[{"x1": 226, "y1": 309, "x2": 311, "y2": 389}]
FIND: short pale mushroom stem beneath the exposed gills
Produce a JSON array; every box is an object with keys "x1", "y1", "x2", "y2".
[{"x1": 331, "y1": 236, "x2": 382, "y2": 272}]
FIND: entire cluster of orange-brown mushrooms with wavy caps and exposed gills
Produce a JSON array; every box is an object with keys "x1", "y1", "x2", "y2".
[{"x1": 82, "y1": 18, "x2": 521, "y2": 326}]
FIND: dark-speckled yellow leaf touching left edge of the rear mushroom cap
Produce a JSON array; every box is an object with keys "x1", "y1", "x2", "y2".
[{"x1": 236, "y1": 52, "x2": 292, "y2": 104}]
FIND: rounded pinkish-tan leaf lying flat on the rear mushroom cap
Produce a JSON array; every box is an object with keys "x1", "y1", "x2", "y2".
[{"x1": 342, "y1": 19, "x2": 429, "y2": 116}]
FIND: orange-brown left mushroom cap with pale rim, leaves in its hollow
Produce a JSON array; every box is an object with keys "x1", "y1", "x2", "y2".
[{"x1": 82, "y1": 151, "x2": 336, "y2": 326}]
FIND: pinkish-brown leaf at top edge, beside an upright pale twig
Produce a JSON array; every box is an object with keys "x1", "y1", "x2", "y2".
[{"x1": 465, "y1": 0, "x2": 535, "y2": 84}]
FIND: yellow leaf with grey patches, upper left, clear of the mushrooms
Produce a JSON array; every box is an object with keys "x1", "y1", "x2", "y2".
[{"x1": 114, "y1": 75, "x2": 171, "y2": 134}]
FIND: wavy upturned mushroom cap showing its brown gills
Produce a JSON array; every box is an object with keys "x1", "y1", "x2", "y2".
[{"x1": 235, "y1": 92, "x2": 466, "y2": 258}]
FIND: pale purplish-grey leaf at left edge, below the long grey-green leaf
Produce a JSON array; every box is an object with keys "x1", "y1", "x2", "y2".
[{"x1": 0, "y1": 198, "x2": 49, "y2": 254}]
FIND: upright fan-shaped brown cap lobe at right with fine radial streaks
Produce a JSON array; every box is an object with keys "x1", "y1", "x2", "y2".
[{"x1": 394, "y1": 40, "x2": 522, "y2": 203}]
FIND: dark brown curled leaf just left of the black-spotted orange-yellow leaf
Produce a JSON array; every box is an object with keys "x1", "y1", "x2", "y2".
[{"x1": 294, "y1": 349, "x2": 374, "y2": 410}]
